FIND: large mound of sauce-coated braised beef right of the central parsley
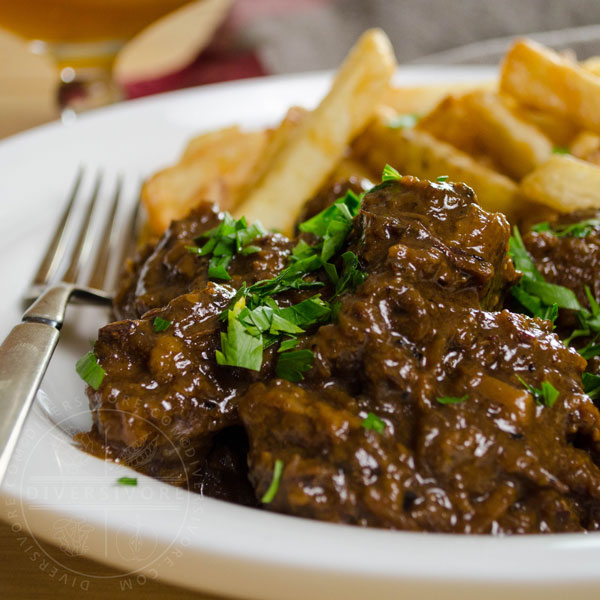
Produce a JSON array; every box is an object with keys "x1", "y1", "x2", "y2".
[{"x1": 239, "y1": 177, "x2": 600, "y2": 533}]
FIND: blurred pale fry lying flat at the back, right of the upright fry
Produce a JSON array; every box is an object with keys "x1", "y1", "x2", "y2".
[{"x1": 381, "y1": 79, "x2": 497, "y2": 116}]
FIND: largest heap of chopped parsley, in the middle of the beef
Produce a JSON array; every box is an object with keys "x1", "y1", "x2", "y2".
[{"x1": 214, "y1": 191, "x2": 366, "y2": 382}]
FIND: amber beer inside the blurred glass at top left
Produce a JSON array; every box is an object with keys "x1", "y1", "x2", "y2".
[{"x1": 0, "y1": 0, "x2": 190, "y2": 44}]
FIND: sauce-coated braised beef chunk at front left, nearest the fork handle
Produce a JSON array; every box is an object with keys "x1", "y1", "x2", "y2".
[{"x1": 88, "y1": 282, "x2": 278, "y2": 494}]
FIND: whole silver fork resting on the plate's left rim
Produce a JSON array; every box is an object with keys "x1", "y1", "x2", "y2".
[{"x1": 0, "y1": 170, "x2": 139, "y2": 484}]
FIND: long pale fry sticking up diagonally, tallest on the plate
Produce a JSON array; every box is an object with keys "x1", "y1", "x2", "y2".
[{"x1": 236, "y1": 29, "x2": 396, "y2": 232}]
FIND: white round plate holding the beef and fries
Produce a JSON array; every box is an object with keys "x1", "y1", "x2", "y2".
[{"x1": 0, "y1": 67, "x2": 600, "y2": 600}]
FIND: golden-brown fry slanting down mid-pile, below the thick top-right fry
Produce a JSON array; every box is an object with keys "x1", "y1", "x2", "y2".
[{"x1": 463, "y1": 92, "x2": 553, "y2": 180}]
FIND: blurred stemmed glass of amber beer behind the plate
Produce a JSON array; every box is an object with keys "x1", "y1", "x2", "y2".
[{"x1": 0, "y1": 0, "x2": 190, "y2": 114}]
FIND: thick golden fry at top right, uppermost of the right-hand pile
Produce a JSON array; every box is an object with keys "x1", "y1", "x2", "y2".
[{"x1": 500, "y1": 40, "x2": 600, "y2": 133}]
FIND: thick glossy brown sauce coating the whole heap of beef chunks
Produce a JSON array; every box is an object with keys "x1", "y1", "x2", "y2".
[{"x1": 80, "y1": 177, "x2": 600, "y2": 533}]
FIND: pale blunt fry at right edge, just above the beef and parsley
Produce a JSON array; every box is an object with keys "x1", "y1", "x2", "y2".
[{"x1": 521, "y1": 155, "x2": 600, "y2": 213}]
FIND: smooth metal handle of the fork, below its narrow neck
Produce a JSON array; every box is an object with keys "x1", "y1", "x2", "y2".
[{"x1": 0, "y1": 286, "x2": 72, "y2": 484}]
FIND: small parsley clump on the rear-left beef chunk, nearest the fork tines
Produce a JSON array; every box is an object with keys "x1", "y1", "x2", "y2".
[{"x1": 186, "y1": 213, "x2": 266, "y2": 281}]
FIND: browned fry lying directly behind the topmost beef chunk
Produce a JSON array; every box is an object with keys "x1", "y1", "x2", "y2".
[{"x1": 355, "y1": 119, "x2": 520, "y2": 218}]
